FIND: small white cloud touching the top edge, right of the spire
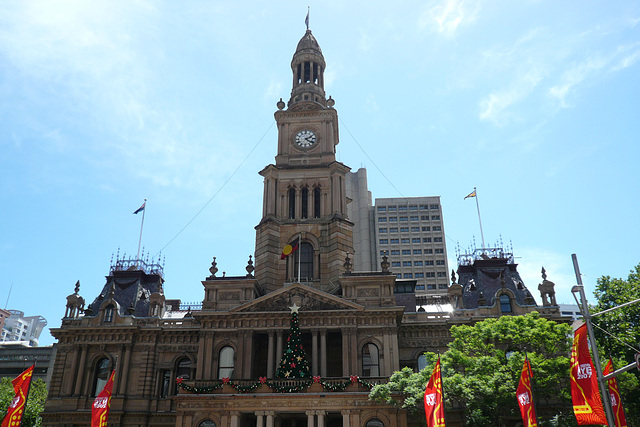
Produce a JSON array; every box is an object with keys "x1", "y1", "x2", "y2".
[{"x1": 418, "y1": 0, "x2": 480, "y2": 37}]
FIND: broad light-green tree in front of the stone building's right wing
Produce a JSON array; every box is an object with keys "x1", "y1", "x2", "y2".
[{"x1": 370, "y1": 313, "x2": 575, "y2": 426}]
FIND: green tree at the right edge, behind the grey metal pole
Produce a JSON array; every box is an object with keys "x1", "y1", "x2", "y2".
[{"x1": 590, "y1": 264, "x2": 640, "y2": 427}]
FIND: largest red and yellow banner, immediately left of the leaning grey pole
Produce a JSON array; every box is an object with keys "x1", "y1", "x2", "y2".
[{"x1": 571, "y1": 324, "x2": 607, "y2": 425}]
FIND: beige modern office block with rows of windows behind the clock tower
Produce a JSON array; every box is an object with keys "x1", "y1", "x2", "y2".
[{"x1": 374, "y1": 196, "x2": 449, "y2": 294}]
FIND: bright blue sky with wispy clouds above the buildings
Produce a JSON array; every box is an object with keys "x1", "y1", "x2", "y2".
[{"x1": 0, "y1": 0, "x2": 640, "y2": 344}]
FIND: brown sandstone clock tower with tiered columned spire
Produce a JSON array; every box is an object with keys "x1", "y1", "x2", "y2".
[{"x1": 255, "y1": 29, "x2": 353, "y2": 292}]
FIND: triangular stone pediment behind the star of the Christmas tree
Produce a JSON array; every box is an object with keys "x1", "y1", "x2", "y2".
[{"x1": 229, "y1": 283, "x2": 364, "y2": 312}]
